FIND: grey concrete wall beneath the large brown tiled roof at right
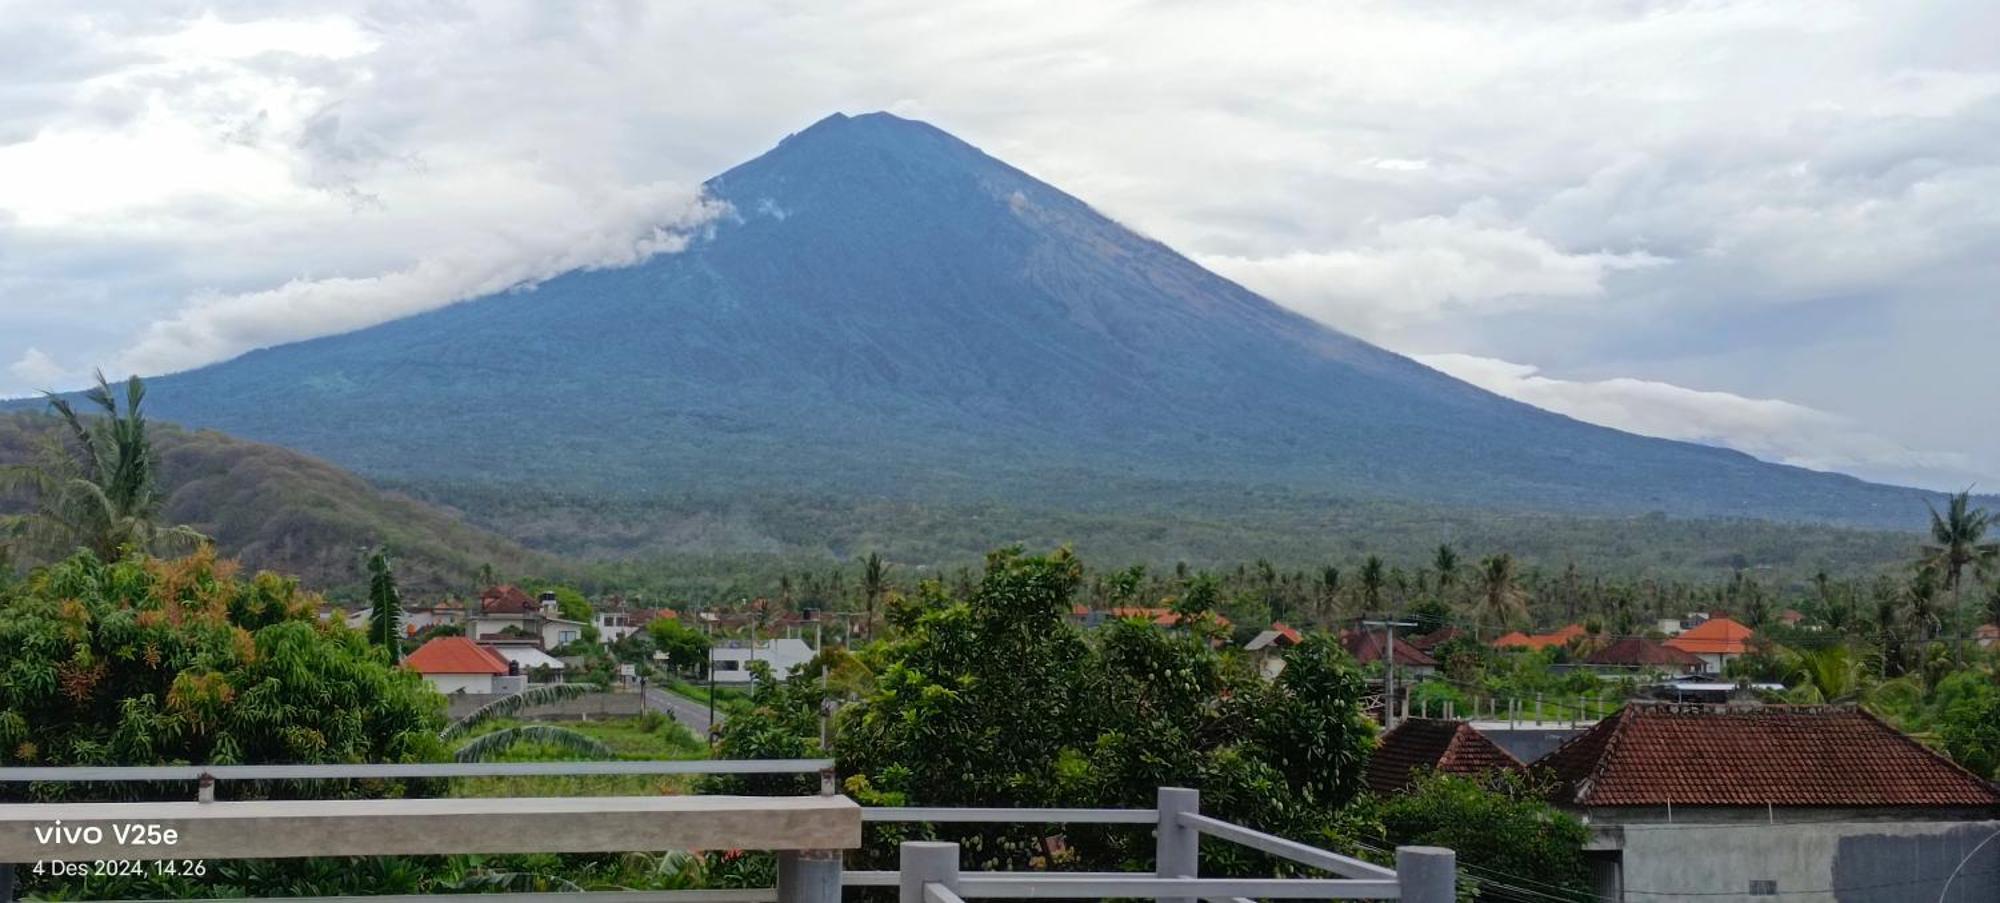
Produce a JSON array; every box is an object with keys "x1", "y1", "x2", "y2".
[{"x1": 1592, "y1": 811, "x2": 2000, "y2": 903}]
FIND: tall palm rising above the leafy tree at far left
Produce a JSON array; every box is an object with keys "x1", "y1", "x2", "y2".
[{"x1": 4, "y1": 372, "x2": 206, "y2": 561}]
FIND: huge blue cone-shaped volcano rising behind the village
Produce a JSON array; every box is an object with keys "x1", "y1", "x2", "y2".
[{"x1": 35, "y1": 114, "x2": 1952, "y2": 527}]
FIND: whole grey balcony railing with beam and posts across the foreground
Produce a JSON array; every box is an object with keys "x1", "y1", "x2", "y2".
[{"x1": 0, "y1": 759, "x2": 1456, "y2": 903}]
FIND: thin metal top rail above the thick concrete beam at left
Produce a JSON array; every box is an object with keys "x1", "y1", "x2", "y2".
[{"x1": 0, "y1": 759, "x2": 834, "y2": 783}]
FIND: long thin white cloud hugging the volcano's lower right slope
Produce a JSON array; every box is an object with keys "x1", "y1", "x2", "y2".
[{"x1": 1416, "y1": 354, "x2": 1978, "y2": 489}]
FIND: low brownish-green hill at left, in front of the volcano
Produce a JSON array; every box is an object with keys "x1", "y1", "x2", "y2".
[{"x1": 0, "y1": 414, "x2": 546, "y2": 595}]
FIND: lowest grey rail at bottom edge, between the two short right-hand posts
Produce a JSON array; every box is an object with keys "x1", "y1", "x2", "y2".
[{"x1": 958, "y1": 871, "x2": 1402, "y2": 899}]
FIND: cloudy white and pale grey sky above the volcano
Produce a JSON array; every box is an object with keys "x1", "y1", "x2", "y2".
[{"x1": 0, "y1": 0, "x2": 2000, "y2": 491}]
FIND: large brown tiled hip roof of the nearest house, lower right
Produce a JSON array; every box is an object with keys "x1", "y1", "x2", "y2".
[{"x1": 1534, "y1": 703, "x2": 2000, "y2": 807}]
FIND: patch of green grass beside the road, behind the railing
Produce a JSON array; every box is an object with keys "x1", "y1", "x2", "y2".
[{"x1": 452, "y1": 713, "x2": 708, "y2": 797}]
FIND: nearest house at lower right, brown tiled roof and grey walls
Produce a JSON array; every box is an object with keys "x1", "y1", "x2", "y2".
[{"x1": 1532, "y1": 703, "x2": 2000, "y2": 903}]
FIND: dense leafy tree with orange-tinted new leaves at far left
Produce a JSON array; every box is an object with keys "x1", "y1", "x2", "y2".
[{"x1": 0, "y1": 549, "x2": 444, "y2": 797}]
